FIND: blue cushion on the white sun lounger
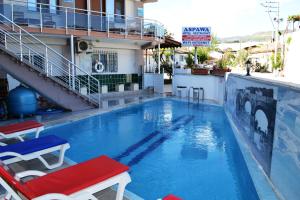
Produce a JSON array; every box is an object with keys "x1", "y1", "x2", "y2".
[{"x1": 0, "y1": 135, "x2": 68, "y2": 160}]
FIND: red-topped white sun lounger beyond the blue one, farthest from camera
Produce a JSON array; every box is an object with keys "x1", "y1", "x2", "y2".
[{"x1": 0, "y1": 121, "x2": 44, "y2": 145}]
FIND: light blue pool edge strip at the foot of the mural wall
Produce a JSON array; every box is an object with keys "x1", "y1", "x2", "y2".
[{"x1": 224, "y1": 109, "x2": 283, "y2": 200}]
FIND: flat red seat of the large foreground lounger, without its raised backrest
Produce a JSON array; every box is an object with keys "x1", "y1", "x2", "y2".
[{"x1": 24, "y1": 156, "x2": 129, "y2": 198}]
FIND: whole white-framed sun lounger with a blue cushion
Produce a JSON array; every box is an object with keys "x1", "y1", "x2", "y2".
[{"x1": 0, "y1": 135, "x2": 70, "y2": 169}]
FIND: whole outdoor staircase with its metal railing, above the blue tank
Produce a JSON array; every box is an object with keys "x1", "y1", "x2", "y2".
[{"x1": 0, "y1": 14, "x2": 100, "y2": 111}]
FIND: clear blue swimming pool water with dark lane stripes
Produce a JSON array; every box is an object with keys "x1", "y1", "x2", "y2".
[{"x1": 44, "y1": 99, "x2": 258, "y2": 200}]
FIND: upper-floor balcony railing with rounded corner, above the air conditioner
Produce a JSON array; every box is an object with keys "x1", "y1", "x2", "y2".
[{"x1": 0, "y1": 0, "x2": 165, "y2": 40}]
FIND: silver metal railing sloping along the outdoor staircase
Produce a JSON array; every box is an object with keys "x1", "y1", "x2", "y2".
[{"x1": 0, "y1": 13, "x2": 100, "y2": 106}]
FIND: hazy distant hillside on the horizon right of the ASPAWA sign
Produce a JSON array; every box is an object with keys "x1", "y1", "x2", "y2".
[{"x1": 219, "y1": 31, "x2": 272, "y2": 43}]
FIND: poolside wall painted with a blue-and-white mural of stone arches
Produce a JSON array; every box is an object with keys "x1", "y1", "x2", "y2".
[{"x1": 225, "y1": 75, "x2": 300, "y2": 199}]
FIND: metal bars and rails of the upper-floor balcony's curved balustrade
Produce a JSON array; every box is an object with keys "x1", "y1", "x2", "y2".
[{"x1": 2, "y1": 0, "x2": 164, "y2": 40}]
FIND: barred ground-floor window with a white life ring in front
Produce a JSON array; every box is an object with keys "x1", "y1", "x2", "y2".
[{"x1": 92, "y1": 50, "x2": 118, "y2": 73}]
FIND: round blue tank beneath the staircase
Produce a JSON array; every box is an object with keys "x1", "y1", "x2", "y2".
[{"x1": 8, "y1": 85, "x2": 37, "y2": 117}]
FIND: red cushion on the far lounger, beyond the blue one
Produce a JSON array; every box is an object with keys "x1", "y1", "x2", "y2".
[{"x1": 0, "y1": 121, "x2": 43, "y2": 134}]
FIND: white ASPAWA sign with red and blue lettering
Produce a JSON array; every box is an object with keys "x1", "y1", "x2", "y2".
[{"x1": 182, "y1": 27, "x2": 211, "y2": 47}]
